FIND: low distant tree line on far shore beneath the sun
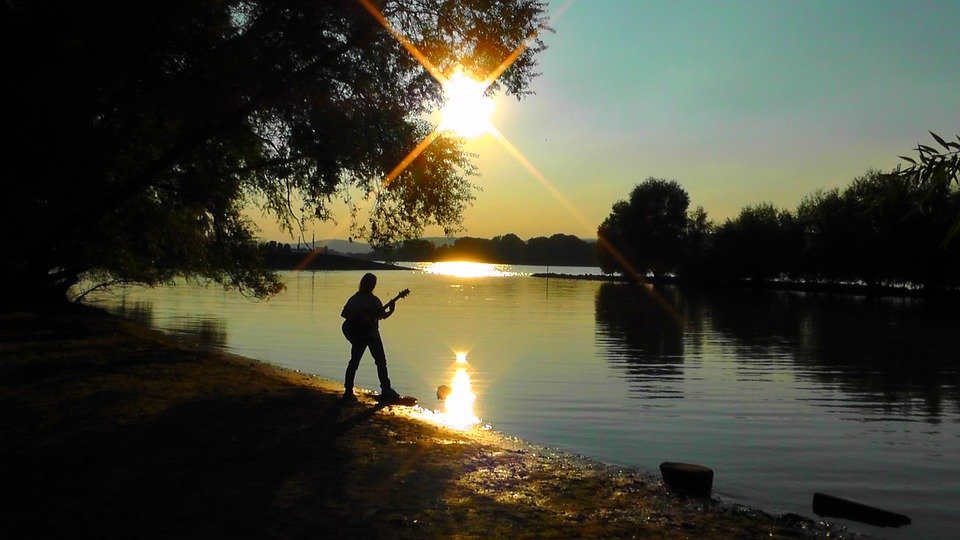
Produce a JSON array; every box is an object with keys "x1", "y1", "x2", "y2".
[{"x1": 371, "y1": 233, "x2": 597, "y2": 266}]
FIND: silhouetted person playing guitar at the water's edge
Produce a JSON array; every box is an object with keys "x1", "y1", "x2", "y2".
[{"x1": 340, "y1": 273, "x2": 400, "y2": 403}]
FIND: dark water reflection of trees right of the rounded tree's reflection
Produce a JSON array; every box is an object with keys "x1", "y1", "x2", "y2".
[{"x1": 710, "y1": 291, "x2": 960, "y2": 423}]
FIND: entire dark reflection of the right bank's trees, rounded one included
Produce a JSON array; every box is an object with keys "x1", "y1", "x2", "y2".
[{"x1": 596, "y1": 284, "x2": 960, "y2": 423}]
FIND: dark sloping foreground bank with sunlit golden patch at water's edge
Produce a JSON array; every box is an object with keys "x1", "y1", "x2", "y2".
[{"x1": 0, "y1": 307, "x2": 856, "y2": 538}]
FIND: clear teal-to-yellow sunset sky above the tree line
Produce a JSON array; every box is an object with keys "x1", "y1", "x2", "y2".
[{"x1": 253, "y1": 0, "x2": 960, "y2": 241}]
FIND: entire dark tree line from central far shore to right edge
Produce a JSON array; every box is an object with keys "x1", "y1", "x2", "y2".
[{"x1": 265, "y1": 131, "x2": 960, "y2": 291}]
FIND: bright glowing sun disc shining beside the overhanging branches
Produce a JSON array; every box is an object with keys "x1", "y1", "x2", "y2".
[{"x1": 440, "y1": 71, "x2": 493, "y2": 138}]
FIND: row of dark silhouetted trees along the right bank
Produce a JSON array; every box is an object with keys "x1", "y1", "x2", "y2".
[{"x1": 598, "y1": 162, "x2": 960, "y2": 290}]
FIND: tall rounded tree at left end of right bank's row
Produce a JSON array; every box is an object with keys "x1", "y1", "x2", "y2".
[{"x1": 597, "y1": 177, "x2": 690, "y2": 276}]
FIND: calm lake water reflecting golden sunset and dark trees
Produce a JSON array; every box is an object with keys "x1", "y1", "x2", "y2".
[{"x1": 84, "y1": 267, "x2": 960, "y2": 538}]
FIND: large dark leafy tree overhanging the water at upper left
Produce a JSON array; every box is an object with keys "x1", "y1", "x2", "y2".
[{"x1": 0, "y1": 0, "x2": 545, "y2": 298}]
